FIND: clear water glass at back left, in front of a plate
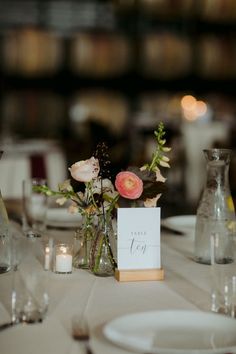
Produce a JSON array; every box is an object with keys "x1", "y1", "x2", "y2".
[{"x1": 23, "y1": 178, "x2": 47, "y2": 237}]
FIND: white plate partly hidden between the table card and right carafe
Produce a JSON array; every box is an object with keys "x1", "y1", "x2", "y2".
[{"x1": 162, "y1": 215, "x2": 196, "y2": 233}]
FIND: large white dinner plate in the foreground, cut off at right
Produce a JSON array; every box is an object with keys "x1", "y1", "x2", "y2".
[{"x1": 104, "y1": 310, "x2": 236, "y2": 354}]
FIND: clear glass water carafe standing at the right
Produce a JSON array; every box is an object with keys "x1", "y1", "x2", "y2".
[{"x1": 194, "y1": 149, "x2": 235, "y2": 264}]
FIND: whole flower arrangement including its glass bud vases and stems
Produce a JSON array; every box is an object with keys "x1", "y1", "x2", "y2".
[{"x1": 36, "y1": 123, "x2": 171, "y2": 276}]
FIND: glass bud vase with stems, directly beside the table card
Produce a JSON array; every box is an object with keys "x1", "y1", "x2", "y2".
[{"x1": 89, "y1": 215, "x2": 116, "y2": 277}]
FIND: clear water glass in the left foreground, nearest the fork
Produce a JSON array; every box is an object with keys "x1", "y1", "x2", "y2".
[{"x1": 11, "y1": 238, "x2": 49, "y2": 323}]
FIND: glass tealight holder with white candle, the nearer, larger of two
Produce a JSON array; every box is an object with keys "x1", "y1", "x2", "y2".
[{"x1": 53, "y1": 243, "x2": 73, "y2": 274}]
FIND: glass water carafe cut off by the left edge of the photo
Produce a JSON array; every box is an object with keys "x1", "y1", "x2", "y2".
[{"x1": 0, "y1": 151, "x2": 11, "y2": 274}]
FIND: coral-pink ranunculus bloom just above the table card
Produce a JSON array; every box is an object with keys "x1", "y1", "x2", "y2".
[{"x1": 115, "y1": 171, "x2": 143, "y2": 199}]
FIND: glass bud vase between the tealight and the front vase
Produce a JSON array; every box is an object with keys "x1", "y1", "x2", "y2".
[{"x1": 73, "y1": 214, "x2": 95, "y2": 269}]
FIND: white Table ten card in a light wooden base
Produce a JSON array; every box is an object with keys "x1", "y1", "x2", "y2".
[{"x1": 115, "y1": 208, "x2": 163, "y2": 281}]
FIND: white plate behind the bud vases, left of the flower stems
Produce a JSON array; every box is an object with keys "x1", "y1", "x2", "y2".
[{"x1": 47, "y1": 208, "x2": 82, "y2": 227}]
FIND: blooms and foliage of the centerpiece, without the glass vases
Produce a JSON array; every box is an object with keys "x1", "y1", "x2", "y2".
[{"x1": 37, "y1": 122, "x2": 171, "y2": 214}]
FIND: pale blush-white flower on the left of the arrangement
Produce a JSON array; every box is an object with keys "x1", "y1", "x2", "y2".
[{"x1": 69, "y1": 156, "x2": 100, "y2": 182}]
